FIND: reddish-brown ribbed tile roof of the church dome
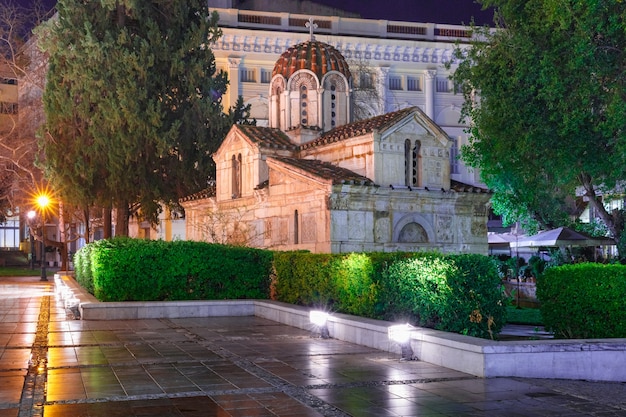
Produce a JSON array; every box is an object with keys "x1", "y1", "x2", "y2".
[{"x1": 272, "y1": 41, "x2": 351, "y2": 80}]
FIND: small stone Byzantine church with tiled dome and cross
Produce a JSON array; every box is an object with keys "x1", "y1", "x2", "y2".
[{"x1": 181, "y1": 32, "x2": 490, "y2": 254}]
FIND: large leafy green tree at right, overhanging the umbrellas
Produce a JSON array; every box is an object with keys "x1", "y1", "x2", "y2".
[{"x1": 453, "y1": 0, "x2": 626, "y2": 256}]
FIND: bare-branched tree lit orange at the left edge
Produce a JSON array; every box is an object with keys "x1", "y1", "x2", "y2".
[{"x1": 0, "y1": 0, "x2": 50, "y2": 222}]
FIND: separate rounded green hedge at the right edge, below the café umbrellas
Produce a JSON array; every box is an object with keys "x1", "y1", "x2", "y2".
[{"x1": 537, "y1": 263, "x2": 626, "y2": 339}]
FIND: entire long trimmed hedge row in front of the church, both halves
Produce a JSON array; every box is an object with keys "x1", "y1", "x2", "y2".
[{"x1": 75, "y1": 238, "x2": 506, "y2": 338}]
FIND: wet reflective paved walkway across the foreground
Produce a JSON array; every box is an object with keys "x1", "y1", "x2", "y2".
[{"x1": 0, "y1": 277, "x2": 626, "y2": 417}]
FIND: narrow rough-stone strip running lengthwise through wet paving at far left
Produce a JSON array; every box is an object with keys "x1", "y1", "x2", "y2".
[{"x1": 18, "y1": 295, "x2": 51, "y2": 417}]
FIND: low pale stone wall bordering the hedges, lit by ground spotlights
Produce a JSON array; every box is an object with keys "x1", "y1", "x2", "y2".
[{"x1": 61, "y1": 272, "x2": 626, "y2": 382}]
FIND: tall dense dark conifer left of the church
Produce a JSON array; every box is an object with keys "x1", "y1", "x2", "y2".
[{"x1": 40, "y1": 0, "x2": 246, "y2": 235}]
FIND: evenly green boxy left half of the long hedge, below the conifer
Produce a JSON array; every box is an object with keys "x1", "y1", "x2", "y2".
[{"x1": 76, "y1": 238, "x2": 272, "y2": 301}]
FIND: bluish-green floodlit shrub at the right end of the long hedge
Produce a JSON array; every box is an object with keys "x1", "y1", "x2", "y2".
[{"x1": 381, "y1": 254, "x2": 506, "y2": 338}]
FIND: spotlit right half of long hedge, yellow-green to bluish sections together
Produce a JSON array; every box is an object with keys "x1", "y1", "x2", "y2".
[{"x1": 274, "y1": 252, "x2": 506, "y2": 338}]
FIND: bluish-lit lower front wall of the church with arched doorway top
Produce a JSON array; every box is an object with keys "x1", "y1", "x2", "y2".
[{"x1": 329, "y1": 186, "x2": 489, "y2": 254}]
